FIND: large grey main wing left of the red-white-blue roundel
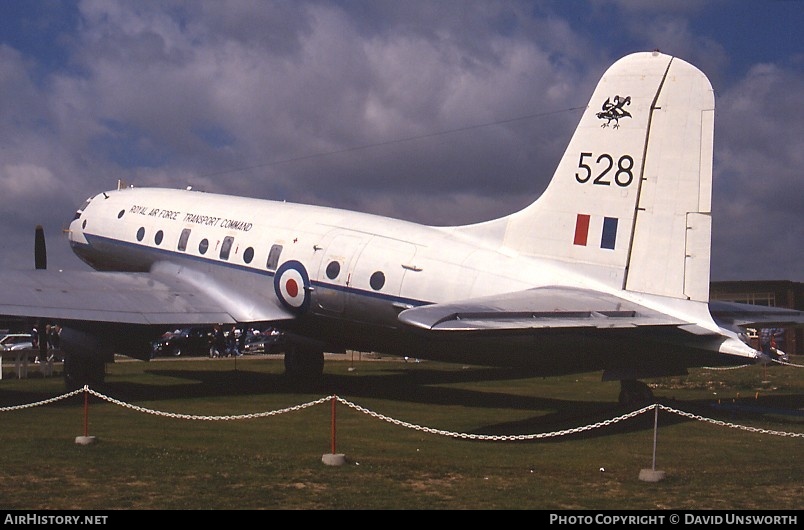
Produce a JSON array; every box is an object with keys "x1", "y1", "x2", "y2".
[{"x1": 0, "y1": 262, "x2": 291, "y2": 325}]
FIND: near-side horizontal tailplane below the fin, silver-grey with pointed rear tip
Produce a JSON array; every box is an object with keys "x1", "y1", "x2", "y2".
[{"x1": 399, "y1": 287, "x2": 690, "y2": 331}]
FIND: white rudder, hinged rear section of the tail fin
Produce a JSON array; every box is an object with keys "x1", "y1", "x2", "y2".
[{"x1": 625, "y1": 59, "x2": 715, "y2": 302}]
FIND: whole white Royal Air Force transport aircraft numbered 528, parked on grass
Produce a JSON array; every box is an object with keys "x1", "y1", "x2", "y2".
[{"x1": 0, "y1": 52, "x2": 804, "y2": 401}]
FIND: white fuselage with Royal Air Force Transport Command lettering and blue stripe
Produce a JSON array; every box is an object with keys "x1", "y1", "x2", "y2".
[{"x1": 62, "y1": 188, "x2": 740, "y2": 373}]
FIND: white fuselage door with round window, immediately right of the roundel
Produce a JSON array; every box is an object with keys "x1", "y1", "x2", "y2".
[{"x1": 314, "y1": 234, "x2": 365, "y2": 313}]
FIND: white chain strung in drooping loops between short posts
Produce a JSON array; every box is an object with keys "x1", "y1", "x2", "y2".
[{"x1": 0, "y1": 386, "x2": 804, "y2": 442}]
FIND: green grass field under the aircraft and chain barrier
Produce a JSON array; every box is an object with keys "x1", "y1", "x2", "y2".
[{"x1": 0, "y1": 352, "x2": 804, "y2": 510}]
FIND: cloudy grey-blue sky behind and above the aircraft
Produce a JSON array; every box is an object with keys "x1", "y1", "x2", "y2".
[{"x1": 0, "y1": 0, "x2": 804, "y2": 281}]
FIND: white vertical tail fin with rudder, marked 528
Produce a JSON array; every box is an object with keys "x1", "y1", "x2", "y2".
[{"x1": 466, "y1": 52, "x2": 714, "y2": 301}]
